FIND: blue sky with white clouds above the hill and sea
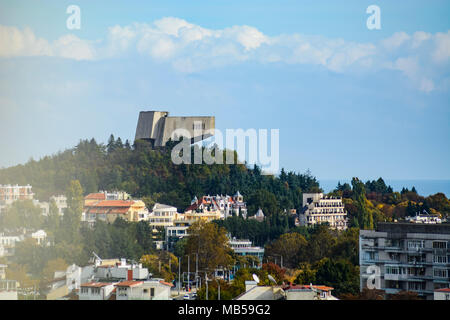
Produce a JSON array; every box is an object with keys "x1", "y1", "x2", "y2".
[{"x1": 0, "y1": 0, "x2": 450, "y2": 179}]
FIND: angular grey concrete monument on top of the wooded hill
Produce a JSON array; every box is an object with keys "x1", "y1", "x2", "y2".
[{"x1": 135, "y1": 111, "x2": 215, "y2": 147}]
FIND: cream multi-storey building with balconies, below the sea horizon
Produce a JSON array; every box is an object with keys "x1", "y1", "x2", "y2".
[{"x1": 299, "y1": 193, "x2": 347, "y2": 230}]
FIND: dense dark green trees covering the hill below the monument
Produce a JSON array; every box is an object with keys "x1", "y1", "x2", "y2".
[{"x1": 0, "y1": 135, "x2": 319, "y2": 215}]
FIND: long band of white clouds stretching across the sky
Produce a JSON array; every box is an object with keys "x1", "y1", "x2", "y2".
[{"x1": 0, "y1": 17, "x2": 450, "y2": 92}]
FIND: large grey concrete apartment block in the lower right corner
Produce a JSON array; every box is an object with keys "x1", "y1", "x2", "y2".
[{"x1": 359, "y1": 223, "x2": 450, "y2": 300}]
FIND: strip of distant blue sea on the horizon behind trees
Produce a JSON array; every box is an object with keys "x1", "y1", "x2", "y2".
[{"x1": 319, "y1": 179, "x2": 450, "y2": 198}]
